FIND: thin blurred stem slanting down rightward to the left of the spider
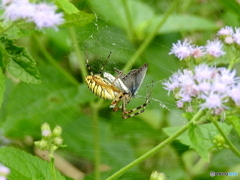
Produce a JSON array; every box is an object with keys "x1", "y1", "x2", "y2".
[{"x1": 33, "y1": 34, "x2": 79, "y2": 85}]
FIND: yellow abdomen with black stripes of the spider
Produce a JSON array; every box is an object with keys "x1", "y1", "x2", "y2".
[{"x1": 85, "y1": 75, "x2": 120, "y2": 100}]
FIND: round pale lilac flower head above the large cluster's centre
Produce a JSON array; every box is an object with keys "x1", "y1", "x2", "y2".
[{"x1": 205, "y1": 39, "x2": 225, "y2": 57}]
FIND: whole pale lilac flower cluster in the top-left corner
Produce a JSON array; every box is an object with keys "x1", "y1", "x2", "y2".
[{"x1": 1, "y1": 0, "x2": 64, "y2": 30}]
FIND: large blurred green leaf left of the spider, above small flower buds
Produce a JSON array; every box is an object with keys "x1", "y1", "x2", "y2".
[{"x1": 0, "y1": 66, "x2": 96, "y2": 139}]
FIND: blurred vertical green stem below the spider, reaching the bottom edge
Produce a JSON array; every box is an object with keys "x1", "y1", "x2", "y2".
[{"x1": 91, "y1": 102, "x2": 101, "y2": 180}]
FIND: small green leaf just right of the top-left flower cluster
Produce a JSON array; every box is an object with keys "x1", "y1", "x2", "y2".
[{"x1": 62, "y1": 11, "x2": 95, "y2": 27}]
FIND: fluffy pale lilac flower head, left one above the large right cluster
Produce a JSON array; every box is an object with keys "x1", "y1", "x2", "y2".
[{"x1": 169, "y1": 39, "x2": 193, "y2": 60}]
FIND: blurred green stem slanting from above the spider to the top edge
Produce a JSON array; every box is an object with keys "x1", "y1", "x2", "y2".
[{"x1": 123, "y1": 0, "x2": 181, "y2": 71}]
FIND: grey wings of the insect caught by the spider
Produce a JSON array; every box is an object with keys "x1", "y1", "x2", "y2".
[{"x1": 115, "y1": 63, "x2": 148, "y2": 96}]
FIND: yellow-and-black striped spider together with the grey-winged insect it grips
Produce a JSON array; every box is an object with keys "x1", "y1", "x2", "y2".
[{"x1": 85, "y1": 52, "x2": 151, "y2": 119}]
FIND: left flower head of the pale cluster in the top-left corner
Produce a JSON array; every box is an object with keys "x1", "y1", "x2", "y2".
[{"x1": 2, "y1": 0, "x2": 35, "y2": 21}]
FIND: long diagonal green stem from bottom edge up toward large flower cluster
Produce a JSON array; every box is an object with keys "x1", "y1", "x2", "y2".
[{"x1": 106, "y1": 110, "x2": 203, "y2": 180}]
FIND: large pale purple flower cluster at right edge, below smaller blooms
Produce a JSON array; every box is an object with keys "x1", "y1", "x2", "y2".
[{"x1": 163, "y1": 64, "x2": 240, "y2": 114}]
